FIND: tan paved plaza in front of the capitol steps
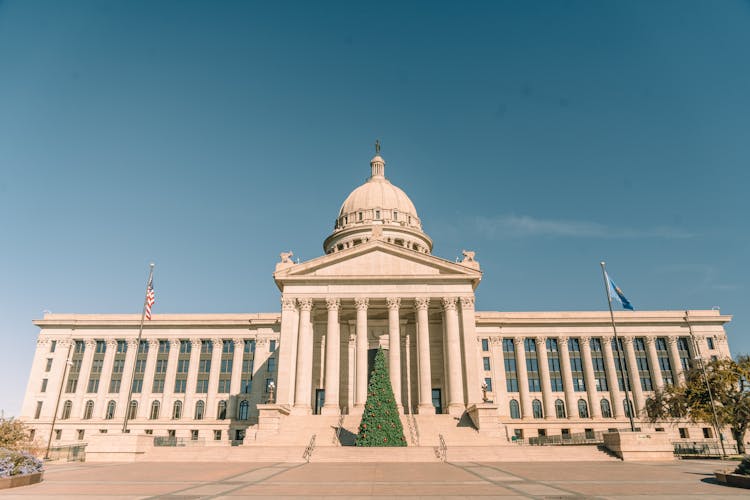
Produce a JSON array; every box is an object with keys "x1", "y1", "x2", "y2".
[{"x1": 0, "y1": 461, "x2": 750, "y2": 500}]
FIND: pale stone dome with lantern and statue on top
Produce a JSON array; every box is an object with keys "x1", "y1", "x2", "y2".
[{"x1": 323, "y1": 150, "x2": 432, "y2": 253}]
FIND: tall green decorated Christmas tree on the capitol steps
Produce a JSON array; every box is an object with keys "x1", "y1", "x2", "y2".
[{"x1": 355, "y1": 349, "x2": 406, "y2": 446}]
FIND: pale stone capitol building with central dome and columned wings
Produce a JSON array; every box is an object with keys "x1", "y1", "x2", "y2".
[{"x1": 21, "y1": 152, "x2": 731, "y2": 458}]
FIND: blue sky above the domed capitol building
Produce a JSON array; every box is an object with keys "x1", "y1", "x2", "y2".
[{"x1": 0, "y1": 0, "x2": 750, "y2": 414}]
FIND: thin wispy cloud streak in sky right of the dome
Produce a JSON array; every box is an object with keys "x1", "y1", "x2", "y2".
[{"x1": 474, "y1": 214, "x2": 694, "y2": 239}]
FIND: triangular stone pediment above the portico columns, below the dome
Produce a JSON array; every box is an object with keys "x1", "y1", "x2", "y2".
[{"x1": 274, "y1": 241, "x2": 481, "y2": 281}]
